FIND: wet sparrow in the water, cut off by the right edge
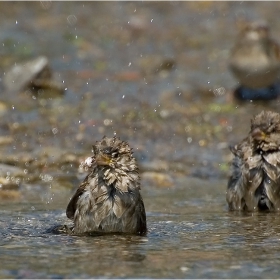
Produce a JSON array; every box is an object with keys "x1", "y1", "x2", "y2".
[{"x1": 226, "y1": 111, "x2": 280, "y2": 211}]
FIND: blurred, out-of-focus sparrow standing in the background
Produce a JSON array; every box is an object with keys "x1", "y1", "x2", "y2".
[{"x1": 229, "y1": 21, "x2": 280, "y2": 99}]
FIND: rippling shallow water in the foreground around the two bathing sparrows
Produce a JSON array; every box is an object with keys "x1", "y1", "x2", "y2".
[{"x1": 0, "y1": 179, "x2": 280, "y2": 278}]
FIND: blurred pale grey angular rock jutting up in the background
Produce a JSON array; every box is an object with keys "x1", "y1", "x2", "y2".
[{"x1": 3, "y1": 56, "x2": 64, "y2": 97}]
